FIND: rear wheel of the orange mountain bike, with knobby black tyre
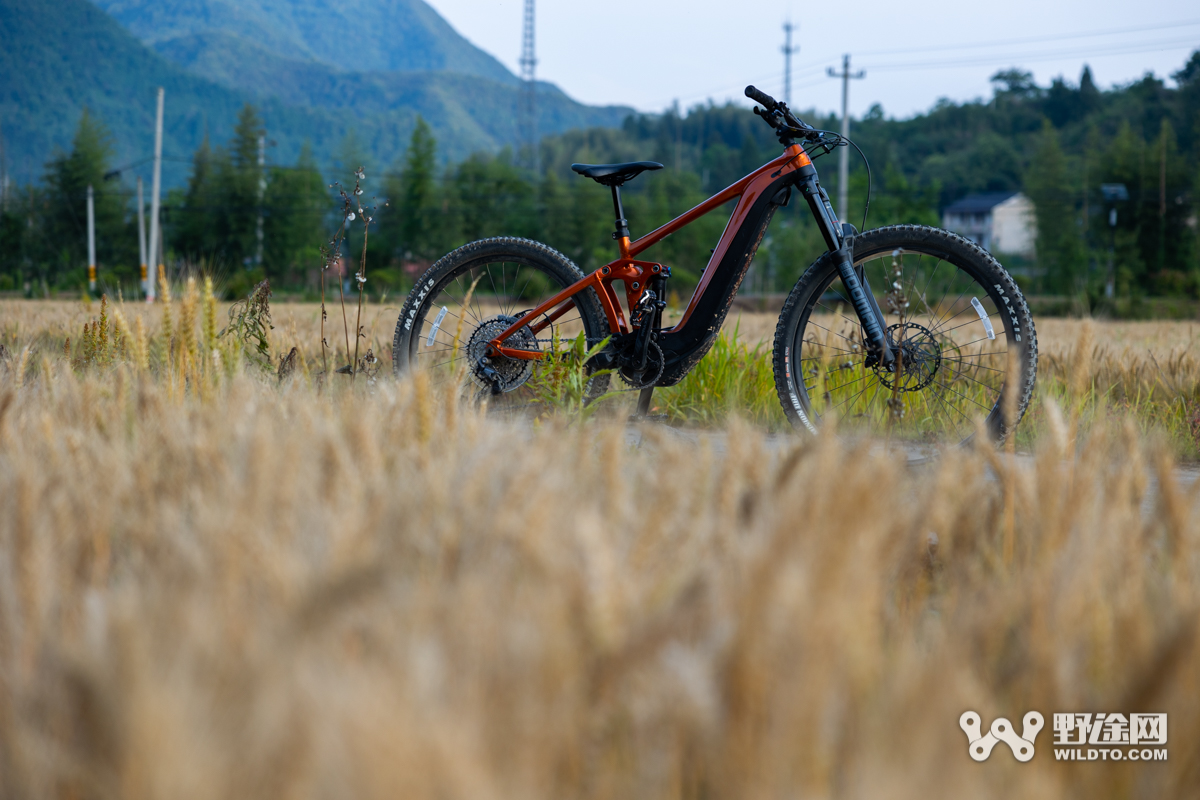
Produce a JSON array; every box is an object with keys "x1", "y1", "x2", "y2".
[{"x1": 391, "y1": 237, "x2": 608, "y2": 402}]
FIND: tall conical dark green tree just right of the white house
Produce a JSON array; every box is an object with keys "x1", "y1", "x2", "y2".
[{"x1": 1025, "y1": 120, "x2": 1086, "y2": 294}]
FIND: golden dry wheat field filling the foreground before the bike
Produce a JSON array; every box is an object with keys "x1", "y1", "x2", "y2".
[{"x1": 0, "y1": 296, "x2": 1200, "y2": 800}]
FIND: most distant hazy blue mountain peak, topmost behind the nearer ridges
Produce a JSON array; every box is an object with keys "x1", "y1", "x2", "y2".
[{"x1": 87, "y1": 0, "x2": 517, "y2": 85}]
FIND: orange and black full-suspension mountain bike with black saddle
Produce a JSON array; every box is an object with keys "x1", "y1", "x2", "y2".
[{"x1": 392, "y1": 86, "x2": 1037, "y2": 445}]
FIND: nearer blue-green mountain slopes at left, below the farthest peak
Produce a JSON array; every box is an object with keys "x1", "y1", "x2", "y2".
[{"x1": 0, "y1": 0, "x2": 628, "y2": 186}]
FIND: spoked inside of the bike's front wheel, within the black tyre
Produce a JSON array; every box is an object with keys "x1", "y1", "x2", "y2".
[{"x1": 785, "y1": 234, "x2": 1036, "y2": 445}]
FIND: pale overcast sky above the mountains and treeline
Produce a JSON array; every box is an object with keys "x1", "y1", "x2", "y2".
[{"x1": 427, "y1": 0, "x2": 1200, "y2": 116}]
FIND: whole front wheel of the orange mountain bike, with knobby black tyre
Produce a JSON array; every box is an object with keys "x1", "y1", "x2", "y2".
[{"x1": 774, "y1": 225, "x2": 1038, "y2": 446}]
